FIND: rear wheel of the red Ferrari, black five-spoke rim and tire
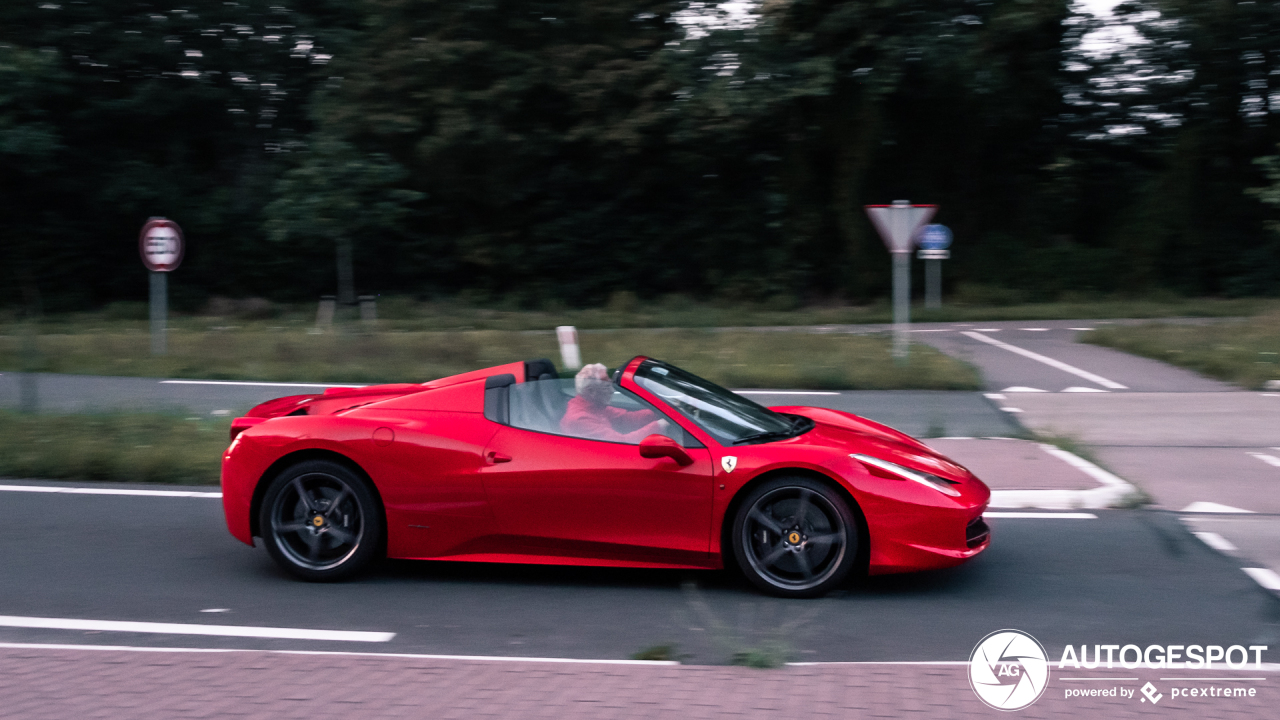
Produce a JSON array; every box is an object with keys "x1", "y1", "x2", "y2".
[{"x1": 259, "y1": 460, "x2": 385, "y2": 582}]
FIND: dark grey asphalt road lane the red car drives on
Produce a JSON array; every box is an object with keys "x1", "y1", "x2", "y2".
[{"x1": 0, "y1": 483, "x2": 1280, "y2": 664}]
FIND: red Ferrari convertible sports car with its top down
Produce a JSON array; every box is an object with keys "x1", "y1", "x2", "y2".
[{"x1": 221, "y1": 356, "x2": 991, "y2": 597}]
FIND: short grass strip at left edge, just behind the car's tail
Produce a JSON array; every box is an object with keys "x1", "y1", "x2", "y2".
[{"x1": 0, "y1": 411, "x2": 230, "y2": 484}]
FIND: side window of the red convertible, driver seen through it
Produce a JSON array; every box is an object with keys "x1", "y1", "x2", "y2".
[{"x1": 508, "y1": 378, "x2": 685, "y2": 445}]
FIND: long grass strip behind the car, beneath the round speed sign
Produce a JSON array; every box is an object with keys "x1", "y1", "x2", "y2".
[{"x1": 0, "y1": 328, "x2": 980, "y2": 389}]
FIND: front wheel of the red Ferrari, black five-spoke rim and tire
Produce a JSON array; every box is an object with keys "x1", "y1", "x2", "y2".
[{"x1": 732, "y1": 477, "x2": 861, "y2": 597}]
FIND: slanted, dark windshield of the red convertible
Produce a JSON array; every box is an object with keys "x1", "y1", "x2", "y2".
[{"x1": 635, "y1": 360, "x2": 809, "y2": 445}]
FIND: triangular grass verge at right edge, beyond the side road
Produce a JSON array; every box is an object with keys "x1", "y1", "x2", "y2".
[{"x1": 1080, "y1": 311, "x2": 1280, "y2": 389}]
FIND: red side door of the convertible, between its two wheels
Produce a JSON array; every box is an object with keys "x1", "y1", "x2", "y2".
[{"x1": 481, "y1": 380, "x2": 712, "y2": 568}]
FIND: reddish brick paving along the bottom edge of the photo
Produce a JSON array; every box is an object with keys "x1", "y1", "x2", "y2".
[{"x1": 0, "y1": 648, "x2": 1280, "y2": 720}]
